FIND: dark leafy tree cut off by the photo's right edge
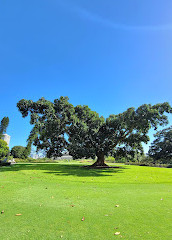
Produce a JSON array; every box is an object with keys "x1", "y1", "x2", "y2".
[{"x1": 148, "y1": 126, "x2": 172, "y2": 163}]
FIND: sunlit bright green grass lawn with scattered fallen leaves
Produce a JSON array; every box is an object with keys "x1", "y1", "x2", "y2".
[{"x1": 0, "y1": 162, "x2": 172, "y2": 240}]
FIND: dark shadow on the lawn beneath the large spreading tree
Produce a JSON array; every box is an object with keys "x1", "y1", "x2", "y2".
[{"x1": 0, "y1": 163, "x2": 126, "y2": 177}]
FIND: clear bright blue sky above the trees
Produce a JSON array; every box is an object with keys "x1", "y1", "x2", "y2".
[{"x1": 0, "y1": 0, "x2": 172, "y2": 153}]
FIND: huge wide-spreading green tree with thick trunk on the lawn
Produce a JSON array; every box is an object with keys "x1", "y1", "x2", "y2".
[{"x1": 17, "y1": 97, "x2": 172, "y2": 166}]
